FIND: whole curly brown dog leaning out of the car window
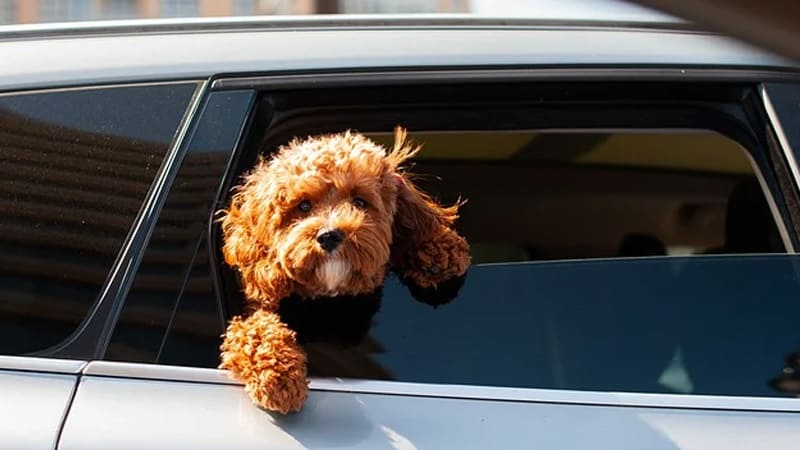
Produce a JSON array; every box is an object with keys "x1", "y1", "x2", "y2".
[{"x1": 220, "y1": 128, "x2": 470, "y2": 414}]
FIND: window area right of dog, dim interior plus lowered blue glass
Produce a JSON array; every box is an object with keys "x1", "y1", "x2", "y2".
[{"x1": 282, "y1": 130, "x2": 800, "y2": 396}]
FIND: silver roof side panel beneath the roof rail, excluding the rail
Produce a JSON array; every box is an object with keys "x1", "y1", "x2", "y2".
[{"x1": 0, "y1": 27, "x2": 792, "y2": 91}]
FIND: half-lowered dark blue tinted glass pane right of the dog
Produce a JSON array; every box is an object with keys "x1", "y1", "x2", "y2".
[{"x1": 310, "y1": 255, "x2": 800, "y2": 396}]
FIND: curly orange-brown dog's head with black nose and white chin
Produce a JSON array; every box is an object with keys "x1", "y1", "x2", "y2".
[{"x1": 222, "y1": 128, "x2": 466, "y2": 307}]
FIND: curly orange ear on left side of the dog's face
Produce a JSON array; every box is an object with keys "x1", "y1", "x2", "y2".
[{"x1": 219, "y1": 158, "x2": 289, "y2": 310}]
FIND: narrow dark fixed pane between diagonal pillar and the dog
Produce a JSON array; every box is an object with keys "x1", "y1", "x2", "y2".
[{"x1": 106, "y1": 91, "x2": 251, "y2": 366}]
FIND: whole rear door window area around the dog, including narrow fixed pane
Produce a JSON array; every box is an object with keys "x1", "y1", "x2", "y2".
[{"x1": 111, "y1": 80, "x2": 800, "y2": 396}]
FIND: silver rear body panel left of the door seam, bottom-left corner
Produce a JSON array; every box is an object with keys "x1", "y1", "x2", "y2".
[{"x1": 0, "y1": 370, "x2": 76, "y2": 450}]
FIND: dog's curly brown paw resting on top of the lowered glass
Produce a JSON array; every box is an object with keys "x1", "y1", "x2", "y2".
[{"x1": 401, "y1": 226, "x2": 470, "y2": 289}]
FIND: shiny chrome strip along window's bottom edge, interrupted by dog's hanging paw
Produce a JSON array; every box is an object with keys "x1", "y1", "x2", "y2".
[{"x1": 82, "y1": 361, "x2": 800, "y2": 413}]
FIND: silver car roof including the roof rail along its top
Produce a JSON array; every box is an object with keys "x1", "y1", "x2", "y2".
[{"x1": 0, "y1": 14, "x2": 796, "y2": 91}]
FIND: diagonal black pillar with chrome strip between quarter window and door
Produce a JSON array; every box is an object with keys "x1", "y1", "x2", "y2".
[{"x1": 32, "y1": 79, "x2": 210, "y2": 360}]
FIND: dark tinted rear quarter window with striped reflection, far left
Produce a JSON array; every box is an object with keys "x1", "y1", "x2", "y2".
[{"x1": 0, "y1": 84, "x2": 195, "y2": 354}]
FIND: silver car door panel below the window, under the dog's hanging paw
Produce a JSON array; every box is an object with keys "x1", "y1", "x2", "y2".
[{"x1": 60, "y1": 363, "x2": 800, "y2": 450}]
